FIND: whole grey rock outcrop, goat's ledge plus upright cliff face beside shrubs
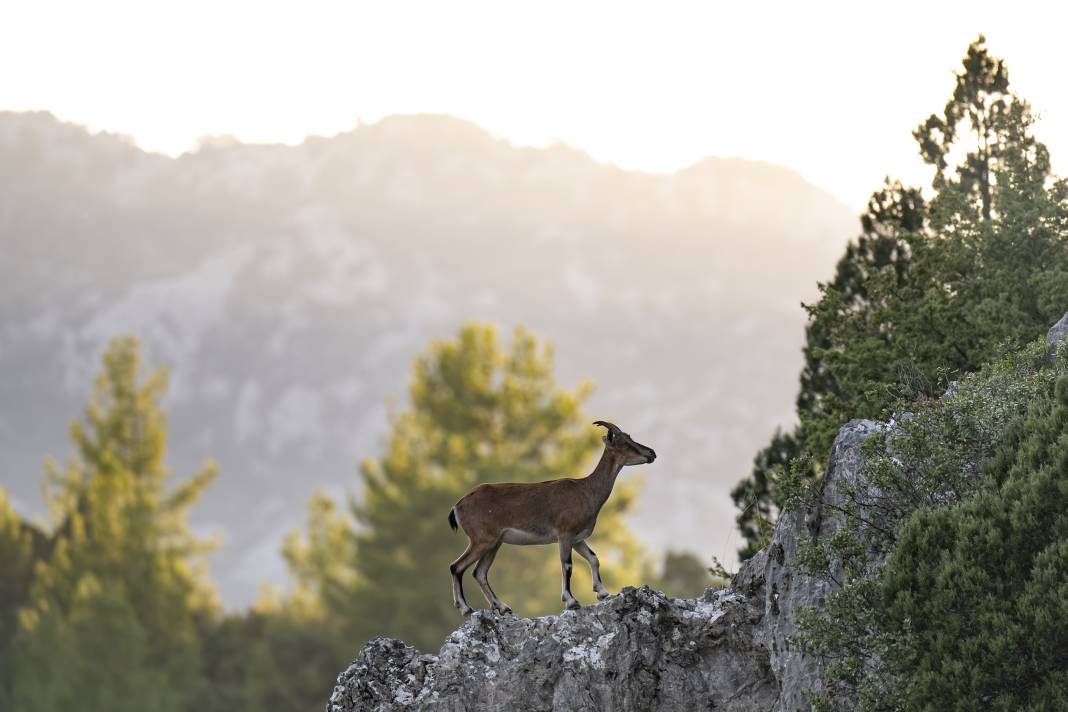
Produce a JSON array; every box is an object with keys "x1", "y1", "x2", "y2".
[{"x1": 327, "y1": 421, "x2": 884, "y2": 712}]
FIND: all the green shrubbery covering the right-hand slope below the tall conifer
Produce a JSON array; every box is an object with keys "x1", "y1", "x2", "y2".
[{"x1": 786, "y1": 342, "x2": 1068, "y2": 711}]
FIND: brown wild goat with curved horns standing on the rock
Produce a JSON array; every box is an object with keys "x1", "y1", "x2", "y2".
[{"x1": 449, "y1": 421, "x2": 657, "y2": 616}]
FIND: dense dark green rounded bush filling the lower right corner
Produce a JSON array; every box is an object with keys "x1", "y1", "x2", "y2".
[{"x1": 868, "y1": 376, "x2": 1068, "y2": 711}]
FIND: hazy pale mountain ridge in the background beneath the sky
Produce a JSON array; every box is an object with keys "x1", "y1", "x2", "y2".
[{"x1": 0, "y1": 113, "x2": 855, "y2": 603}]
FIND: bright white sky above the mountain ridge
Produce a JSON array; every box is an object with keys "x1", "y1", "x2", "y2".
[{"x1": 0, "y1": 0, "x2": 1068, "y2": 209}]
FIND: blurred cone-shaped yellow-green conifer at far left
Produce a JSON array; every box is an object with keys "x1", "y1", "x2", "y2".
[{"x1": 12, "y1": 338, "x2": 215, "y2": 712}]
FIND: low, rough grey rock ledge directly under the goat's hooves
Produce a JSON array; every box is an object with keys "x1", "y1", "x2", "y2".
[{"x1": 327, "y1": 586, "x2": 779, "y2": 712}]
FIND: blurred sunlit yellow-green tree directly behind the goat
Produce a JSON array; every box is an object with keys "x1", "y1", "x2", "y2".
[{"x1": 286, "y1": 325, "x2": 640, "y2": 650}]
